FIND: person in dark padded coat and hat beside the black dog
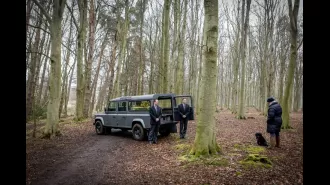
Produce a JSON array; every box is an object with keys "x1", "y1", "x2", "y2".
[{"x1": 267, "y1": 97, "x2": 282, "y2": 148}]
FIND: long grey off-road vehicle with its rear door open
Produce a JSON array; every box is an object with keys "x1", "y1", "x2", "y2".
[{"x1": 93, "y1": 94, "x2": 194, "y2": 140}]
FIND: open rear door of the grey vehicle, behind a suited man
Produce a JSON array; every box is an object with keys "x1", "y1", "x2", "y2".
[{"x1": 173, "y1": 95, "x2": 195, "y2": 121}]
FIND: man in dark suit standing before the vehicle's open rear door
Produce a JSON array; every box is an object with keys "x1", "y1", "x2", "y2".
[{"x1": 178, "y1": 98, "x2": 190, "y2": 139}]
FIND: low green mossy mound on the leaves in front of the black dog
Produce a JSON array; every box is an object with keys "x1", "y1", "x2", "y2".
[{"x1": 239, "y1": 154, "x2": 273, "y2": 168}]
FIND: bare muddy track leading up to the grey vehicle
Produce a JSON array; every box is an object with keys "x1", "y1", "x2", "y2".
[{"x1": 31, "y1": 130, "x2": 136, "y2": 185}]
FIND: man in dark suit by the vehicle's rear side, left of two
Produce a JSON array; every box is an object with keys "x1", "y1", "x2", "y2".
[{"x1": 148, "y1": 99, "x2": 162, "y2": 144}]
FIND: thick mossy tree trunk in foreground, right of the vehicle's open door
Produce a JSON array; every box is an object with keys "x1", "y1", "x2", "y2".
[{"x1": 190, "y1": 0, "x2": 220, "y2": 157}]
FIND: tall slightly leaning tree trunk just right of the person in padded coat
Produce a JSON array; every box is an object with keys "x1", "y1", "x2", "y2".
[{"x1": 282, "y1": 0, "x2": 300, "y2": 129}]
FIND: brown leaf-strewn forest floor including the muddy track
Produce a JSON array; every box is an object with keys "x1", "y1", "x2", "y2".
[{"x1": 26, "y1": 108, "x2": 303, "y2": 185}]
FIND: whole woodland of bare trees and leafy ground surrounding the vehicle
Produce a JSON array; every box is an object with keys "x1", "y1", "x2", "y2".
[{"x1": 26, "y1": 0, "x2": 303, "y2": 184}]
